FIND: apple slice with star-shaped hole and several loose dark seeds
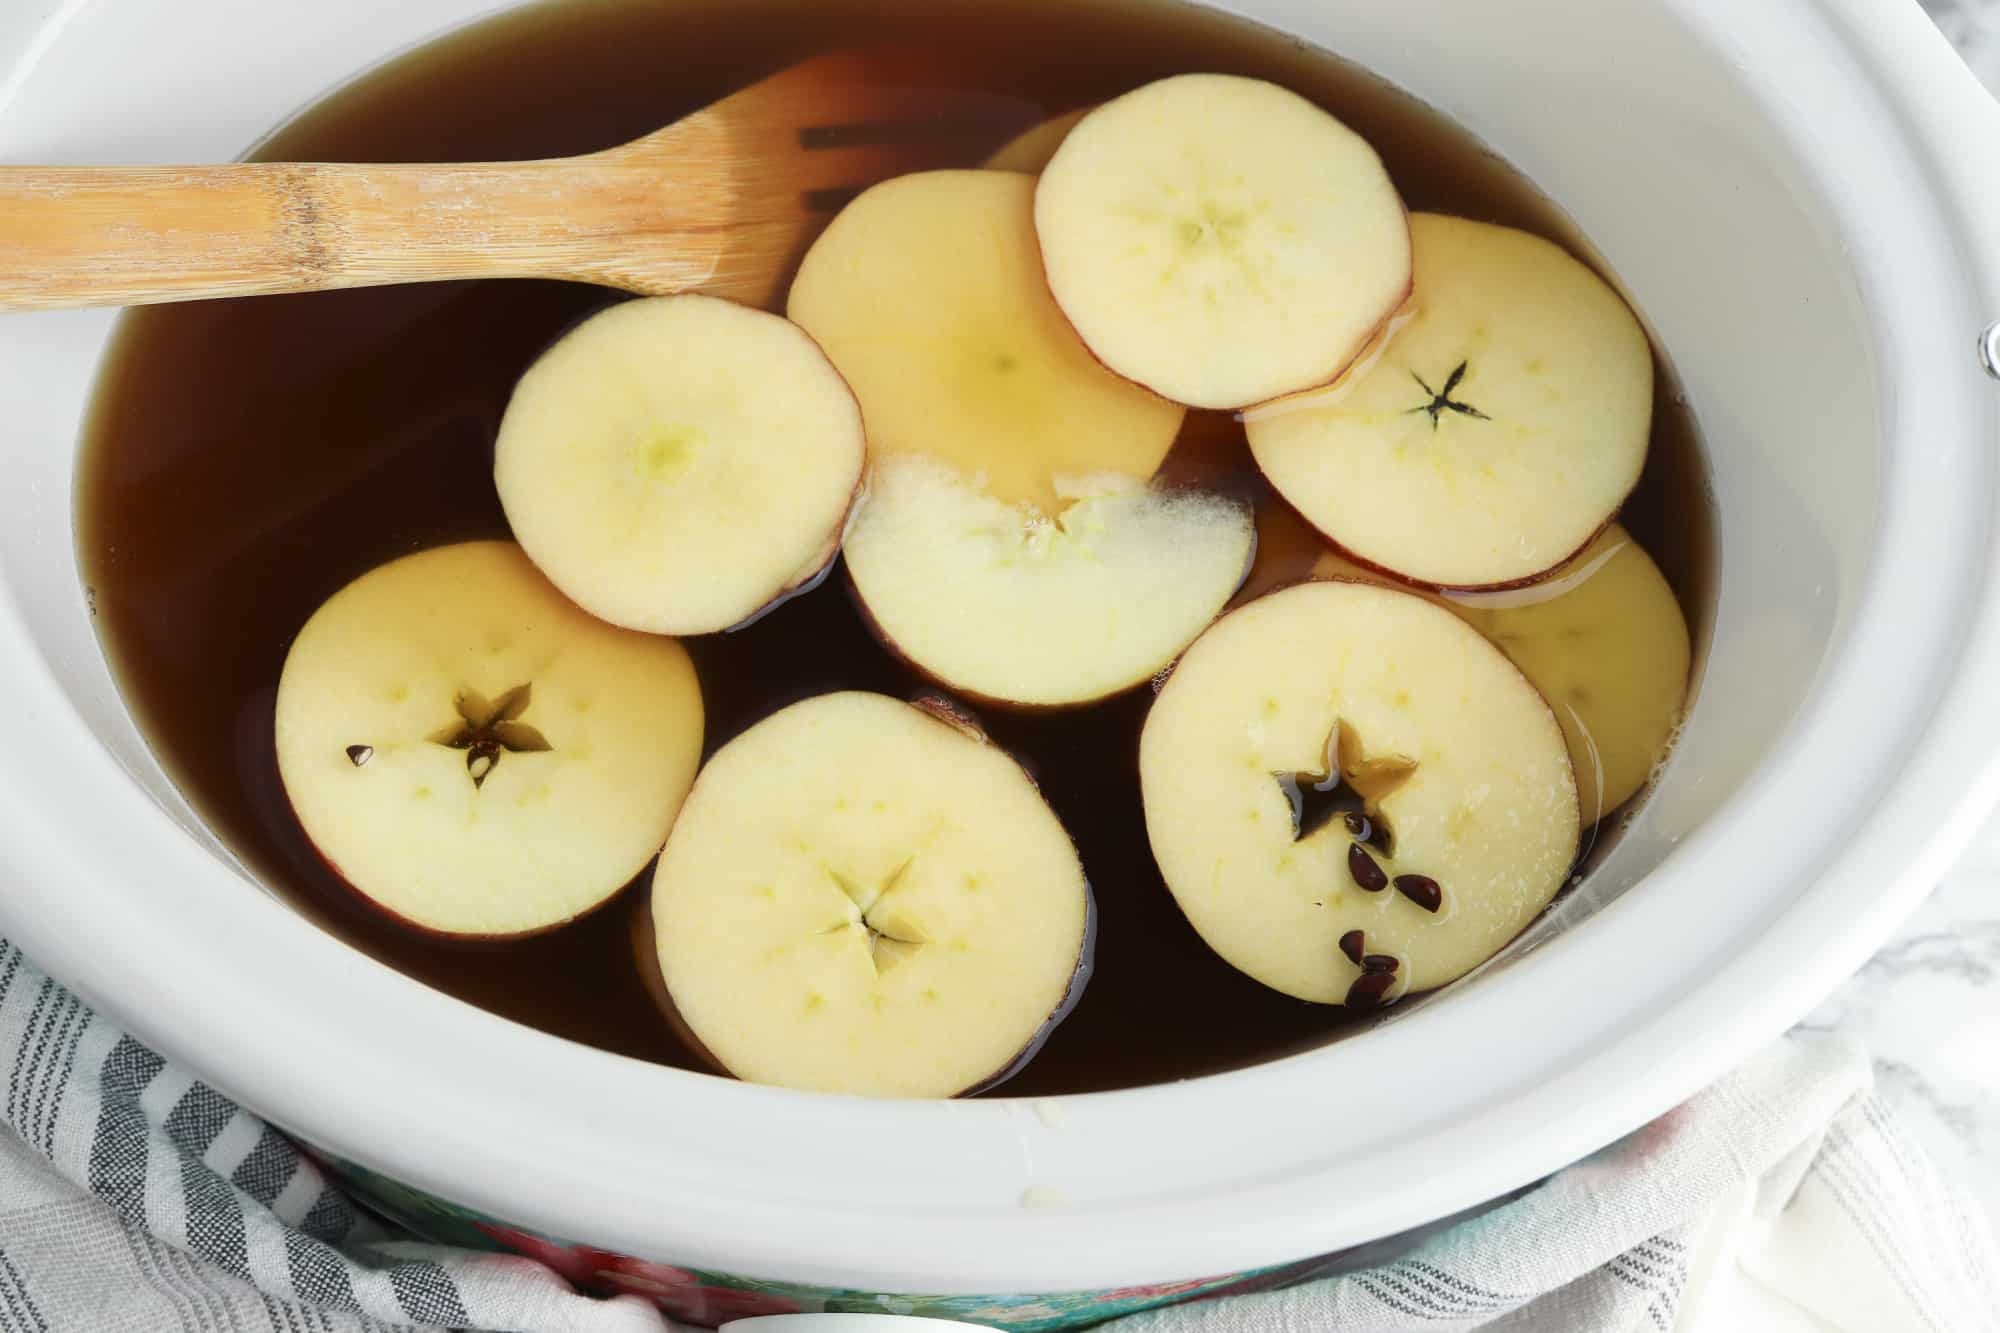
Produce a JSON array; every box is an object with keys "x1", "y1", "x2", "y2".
[{"x1": 1140, "y1": 582, "x2": 1578, "y2": 1009}]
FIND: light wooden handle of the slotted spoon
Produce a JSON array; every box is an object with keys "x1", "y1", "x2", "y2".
[{"x1": 0, "y1": 150, "x2": 720, "y2": 310}]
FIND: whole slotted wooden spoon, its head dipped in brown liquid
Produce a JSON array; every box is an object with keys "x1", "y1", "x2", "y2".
[{"x1": 0, "y1": 48, "x2": 1036, "y2": 310}]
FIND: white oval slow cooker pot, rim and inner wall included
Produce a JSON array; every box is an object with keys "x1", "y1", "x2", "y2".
[{"x1": 0, "y1": 0, "x2": 2000, "y2": 1327}]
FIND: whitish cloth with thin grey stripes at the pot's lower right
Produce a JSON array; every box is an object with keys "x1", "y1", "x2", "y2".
[{"x1": 1116, "y1": 1033, "x2": 2000, "y2": 1333}]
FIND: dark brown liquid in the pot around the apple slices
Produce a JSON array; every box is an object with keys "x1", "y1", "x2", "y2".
[{"x1": 78, "y1": 0, "x2": 1712, "y2": 1095}]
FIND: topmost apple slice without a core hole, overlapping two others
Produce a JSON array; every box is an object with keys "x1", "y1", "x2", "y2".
[{"x1": 1034, "y1": 74, "x2": 1410, "y2": 408}]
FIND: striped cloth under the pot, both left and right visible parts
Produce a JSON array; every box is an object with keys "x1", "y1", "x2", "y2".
[{"x1": 0, "y1": 941, "x2": 2000, "y2": 1333}]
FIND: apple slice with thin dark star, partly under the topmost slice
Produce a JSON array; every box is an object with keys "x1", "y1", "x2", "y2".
[{"x1": 1246, "y1": 214, "x2": 1652, "y2": 588}]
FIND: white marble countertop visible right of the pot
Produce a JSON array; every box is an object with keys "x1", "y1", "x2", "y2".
[{"x1": 1806, "y1": 0, "x2": 2000, "y2": 1235}]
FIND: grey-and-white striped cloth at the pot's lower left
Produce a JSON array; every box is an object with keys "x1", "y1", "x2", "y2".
[{"x1": 0, "y1": 939, "x2": 670, "y2": 1333}]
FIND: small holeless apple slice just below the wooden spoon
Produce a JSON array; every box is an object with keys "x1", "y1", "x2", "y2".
[{"x1": 494, "y1": 294, "x2": 866, "y2": 634}]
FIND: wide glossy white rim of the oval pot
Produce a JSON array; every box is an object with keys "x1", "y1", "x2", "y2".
[{"x1": 0, "y1": 0, "x2": 2000, "y2": 1293}]
